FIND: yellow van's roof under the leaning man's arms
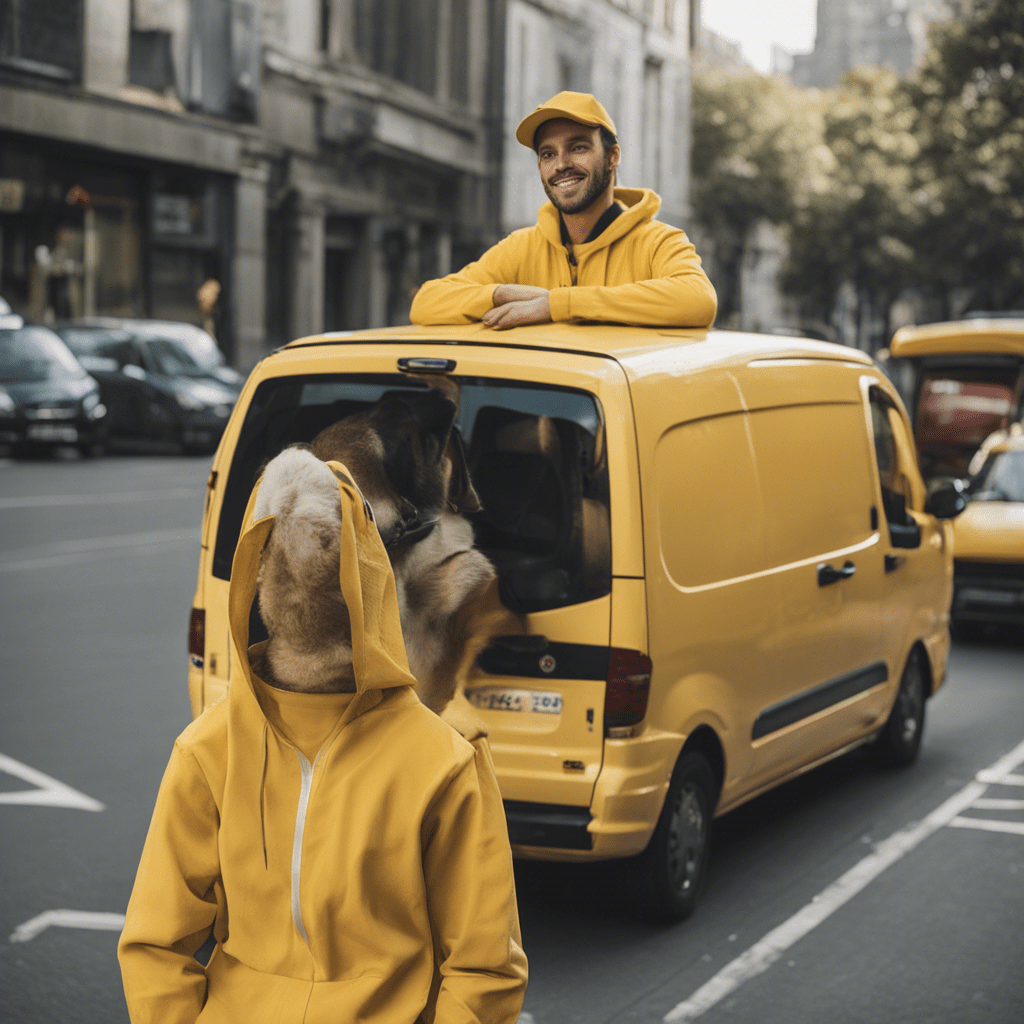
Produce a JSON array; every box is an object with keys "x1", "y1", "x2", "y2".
[{"x1": 286, "y1": 323, "x2": 871, "y2": 369}]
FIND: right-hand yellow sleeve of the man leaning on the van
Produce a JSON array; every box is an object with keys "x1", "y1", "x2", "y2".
[{"x1": 550, "y1": 230, "x2": 718, "y2": 327}]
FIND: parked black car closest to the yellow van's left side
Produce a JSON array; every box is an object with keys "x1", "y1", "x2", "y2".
[{"x1": 54, "y1": 317, "x2": 244, "y2": 453}]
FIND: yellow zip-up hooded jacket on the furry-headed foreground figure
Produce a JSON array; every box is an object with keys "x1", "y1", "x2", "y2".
[{"x1": 118, "y1": 462, "x2": 526, "y2": 1024}]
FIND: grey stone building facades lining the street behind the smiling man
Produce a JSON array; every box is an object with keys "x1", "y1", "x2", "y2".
[{"x1": 0, "y1": 0, "x2": 696, "y2": 370}]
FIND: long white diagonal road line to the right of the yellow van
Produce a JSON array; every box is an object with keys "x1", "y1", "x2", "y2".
[{"x1": 663, "y1": 742, "x2": 1024, "y2": 1024}]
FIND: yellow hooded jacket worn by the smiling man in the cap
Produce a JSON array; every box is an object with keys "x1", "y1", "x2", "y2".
[{"x1": 410, "y1": 188, "x2": 718, "y2": 327}]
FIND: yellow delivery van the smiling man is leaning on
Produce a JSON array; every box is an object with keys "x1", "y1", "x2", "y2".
[{"x1": 188, "y1": 324, "x2": 963, "y2": 920}]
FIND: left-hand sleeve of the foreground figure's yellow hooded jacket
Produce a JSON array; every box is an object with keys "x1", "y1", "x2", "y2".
[{"x1": 118, "y1": 743, "x2": 220, "y2": 1024}]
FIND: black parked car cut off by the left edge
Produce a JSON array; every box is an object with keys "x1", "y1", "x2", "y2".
[{"x1": 0, "y1": 317, "x2": 106, "y2": 456}]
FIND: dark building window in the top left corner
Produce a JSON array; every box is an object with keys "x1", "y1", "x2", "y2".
[{"x1": 0, "y1": 0, "x2": 82, "y2": 82}]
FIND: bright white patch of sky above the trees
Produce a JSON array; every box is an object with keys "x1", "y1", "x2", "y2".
[{"x1": 701, "y1": 0, "x2": 817, "y2": 72}]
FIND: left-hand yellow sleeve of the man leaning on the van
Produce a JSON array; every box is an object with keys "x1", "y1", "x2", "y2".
[{"x1": 409, "y1": 232, "x2": 520, "y2": 326}]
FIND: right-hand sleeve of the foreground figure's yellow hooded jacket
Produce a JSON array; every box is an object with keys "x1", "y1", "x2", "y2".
[{"x1": 424, "y1": 737, "x2": 526, "y2": 1024}]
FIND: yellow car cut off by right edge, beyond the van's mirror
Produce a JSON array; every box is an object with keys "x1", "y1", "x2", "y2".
[{"x1": 952, "y1": 436, "x2": 1024, "y2": 624}]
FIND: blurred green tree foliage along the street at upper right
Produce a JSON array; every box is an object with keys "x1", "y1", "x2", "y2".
[{"x1": 693, "y1": 0, "x2": 1024, "y2": 341}]
